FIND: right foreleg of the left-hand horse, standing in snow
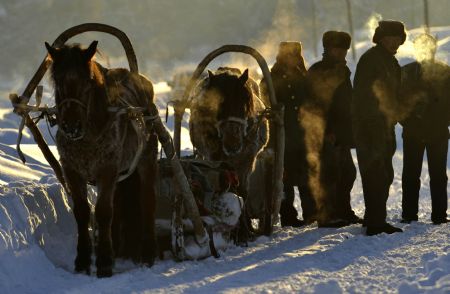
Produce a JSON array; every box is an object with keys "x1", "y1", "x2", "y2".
[{"x1": 95, "y1": 166, "x2": 117, "y2": 278}]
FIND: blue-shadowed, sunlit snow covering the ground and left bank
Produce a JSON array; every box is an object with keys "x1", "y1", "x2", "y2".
[{"x1": 0, "y1": 28, "x2": 450, "y2": 294}]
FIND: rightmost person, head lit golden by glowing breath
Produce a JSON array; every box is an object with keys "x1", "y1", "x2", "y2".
[{"x1": 401, "y1": 33, "x2": 450, "y2": 224}]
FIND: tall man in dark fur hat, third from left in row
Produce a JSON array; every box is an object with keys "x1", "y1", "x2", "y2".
[{"x1": 352, "y1": 20, "x2": 406, "y2": 236}]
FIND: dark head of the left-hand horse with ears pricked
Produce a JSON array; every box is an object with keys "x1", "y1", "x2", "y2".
[{"x1": 45, "y1": 41, "x2": 105, "y2": 141}]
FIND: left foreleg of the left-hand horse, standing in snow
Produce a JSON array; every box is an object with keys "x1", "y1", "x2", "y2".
[{"x1": 64, "y1": 168, "x2": 92, "y2": 275}]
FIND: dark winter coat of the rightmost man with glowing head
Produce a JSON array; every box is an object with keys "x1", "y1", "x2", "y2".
[{"x1": 400, "y1": 62, "x2": 450, "y2": 142}]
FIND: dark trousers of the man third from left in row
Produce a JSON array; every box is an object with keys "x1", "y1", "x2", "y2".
[{"x1": 355, "y1": 125, "x2": 396, "y2": 227}]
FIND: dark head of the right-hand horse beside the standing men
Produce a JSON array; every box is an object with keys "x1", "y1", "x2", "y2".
[{"x1": 207, "y1": 69, "x2": 254, "y2": 155}]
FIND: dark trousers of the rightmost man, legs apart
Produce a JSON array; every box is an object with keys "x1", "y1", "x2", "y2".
[{"x1": 402, "y1": 138, "x2": 448, "y2": 221}]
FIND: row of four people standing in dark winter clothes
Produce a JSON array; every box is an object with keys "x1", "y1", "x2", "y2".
[{"x1": 261, "y1": 21, "x2": 450, "y2": 236}]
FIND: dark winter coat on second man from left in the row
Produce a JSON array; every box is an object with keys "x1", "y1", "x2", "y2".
[{"x1": 308, "y1": 58, "x2": 354, "y2": 147}]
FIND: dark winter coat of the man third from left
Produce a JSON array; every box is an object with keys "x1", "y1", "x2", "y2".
[{"x1": 352, "y1": 45, "x2": 401, "y2": 129}]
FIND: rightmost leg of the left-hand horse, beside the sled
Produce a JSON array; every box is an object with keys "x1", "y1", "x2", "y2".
[{"x1": 138, "y1": 135, "x2": 158, "y2": 267}]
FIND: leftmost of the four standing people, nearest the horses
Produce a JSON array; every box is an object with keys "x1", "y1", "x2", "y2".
[{"x1": 261, "y1": 42, "x2": 315, "y2": 227}]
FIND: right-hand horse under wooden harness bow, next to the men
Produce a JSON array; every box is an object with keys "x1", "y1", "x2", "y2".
[{"x1": 189, "y1": 67, "x2": 269, "y2": 243}]
